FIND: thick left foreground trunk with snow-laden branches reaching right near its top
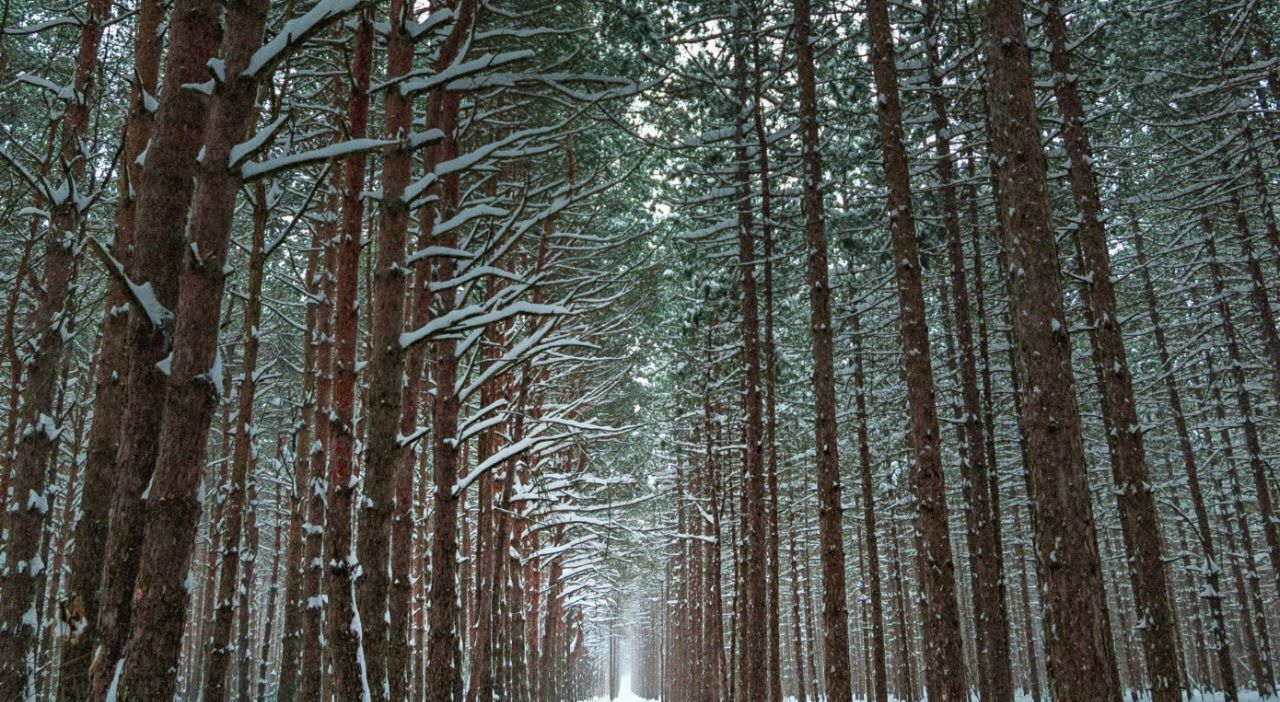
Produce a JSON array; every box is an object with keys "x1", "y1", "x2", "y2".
[{"x1": 113, "y1": 0, "x2": 269, "y2": 699}]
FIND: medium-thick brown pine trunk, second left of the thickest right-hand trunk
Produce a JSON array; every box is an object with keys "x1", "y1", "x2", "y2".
[{"x1": 867, "y1": 0, "x2": 962, "y2": 699}]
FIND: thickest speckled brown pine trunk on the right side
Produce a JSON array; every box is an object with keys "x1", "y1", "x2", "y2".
[{"x1": 983, "y1": 0, "x2": 1120, "y2": 702}]
